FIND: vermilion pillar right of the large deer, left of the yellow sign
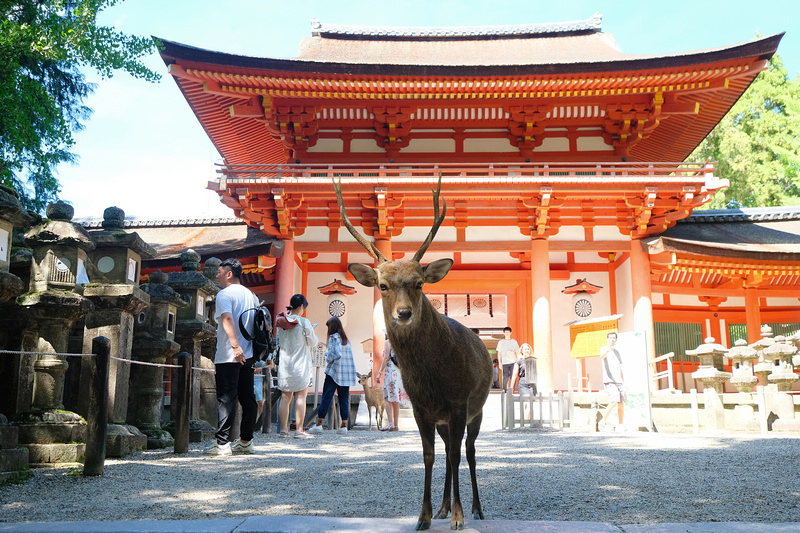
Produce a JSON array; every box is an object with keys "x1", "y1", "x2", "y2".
[{"x1": 531, "y1": 239, "x2": 554, "y2": 391}]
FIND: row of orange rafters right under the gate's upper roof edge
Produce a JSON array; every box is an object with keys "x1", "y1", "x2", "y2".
[{"x1": 169, "y1": 59, "x2": 766, "y2": 101}]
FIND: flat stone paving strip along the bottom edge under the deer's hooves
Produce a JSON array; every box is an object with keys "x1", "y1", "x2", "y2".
[{"x1": 0, "y1": 515, "x2": 800, "y2": 533}]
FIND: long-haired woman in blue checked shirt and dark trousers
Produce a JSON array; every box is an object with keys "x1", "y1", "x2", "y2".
[{"x1": 308, "y1": 316, "x2": 356, "y2": 434}]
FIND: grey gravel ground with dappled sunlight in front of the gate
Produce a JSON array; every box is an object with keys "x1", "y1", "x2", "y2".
[{"x1": 0, "y1": 429, "x2": 800, "y2": 524}]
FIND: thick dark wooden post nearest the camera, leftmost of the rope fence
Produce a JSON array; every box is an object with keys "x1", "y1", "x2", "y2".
[{"x1": 83, "y1": 337, "x2": 111, "y2": 476}]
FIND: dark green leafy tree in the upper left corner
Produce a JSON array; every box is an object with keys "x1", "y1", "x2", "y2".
[{"x1": 0, "y1": 0, "x2": 160, "y2": 212}]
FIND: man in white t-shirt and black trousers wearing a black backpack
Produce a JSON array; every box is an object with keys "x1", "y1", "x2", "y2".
[{"x1": 204, "y1": 259, "x2": 258, "y2": 455}]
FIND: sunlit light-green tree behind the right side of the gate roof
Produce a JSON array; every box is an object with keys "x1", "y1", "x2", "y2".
[{"x1": 687, "y1": 54, "x2": 800, "y2": 209}]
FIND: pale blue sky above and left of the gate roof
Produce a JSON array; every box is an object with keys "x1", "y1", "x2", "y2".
[{"x1": 58, "y1": 0, "x2": 800, "y2": 219}]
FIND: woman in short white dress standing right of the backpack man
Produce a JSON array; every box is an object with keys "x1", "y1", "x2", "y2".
[{"x1": 276, "y1": 294, "x2": 319, "y2": 439}]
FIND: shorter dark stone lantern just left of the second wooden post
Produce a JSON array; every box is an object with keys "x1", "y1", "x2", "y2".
[{"x1": 128, "y1": 270, "x2": 188, "y2": 449}]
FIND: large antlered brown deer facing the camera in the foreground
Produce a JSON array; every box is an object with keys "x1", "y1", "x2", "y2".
[{"x1": 333, "y1": 173, "x2": 492, "y2": 531}]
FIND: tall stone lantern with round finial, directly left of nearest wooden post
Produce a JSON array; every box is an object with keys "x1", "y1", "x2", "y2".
[{"x1": 9, "y1": 202, "x2": 94, "y2": 463}]
